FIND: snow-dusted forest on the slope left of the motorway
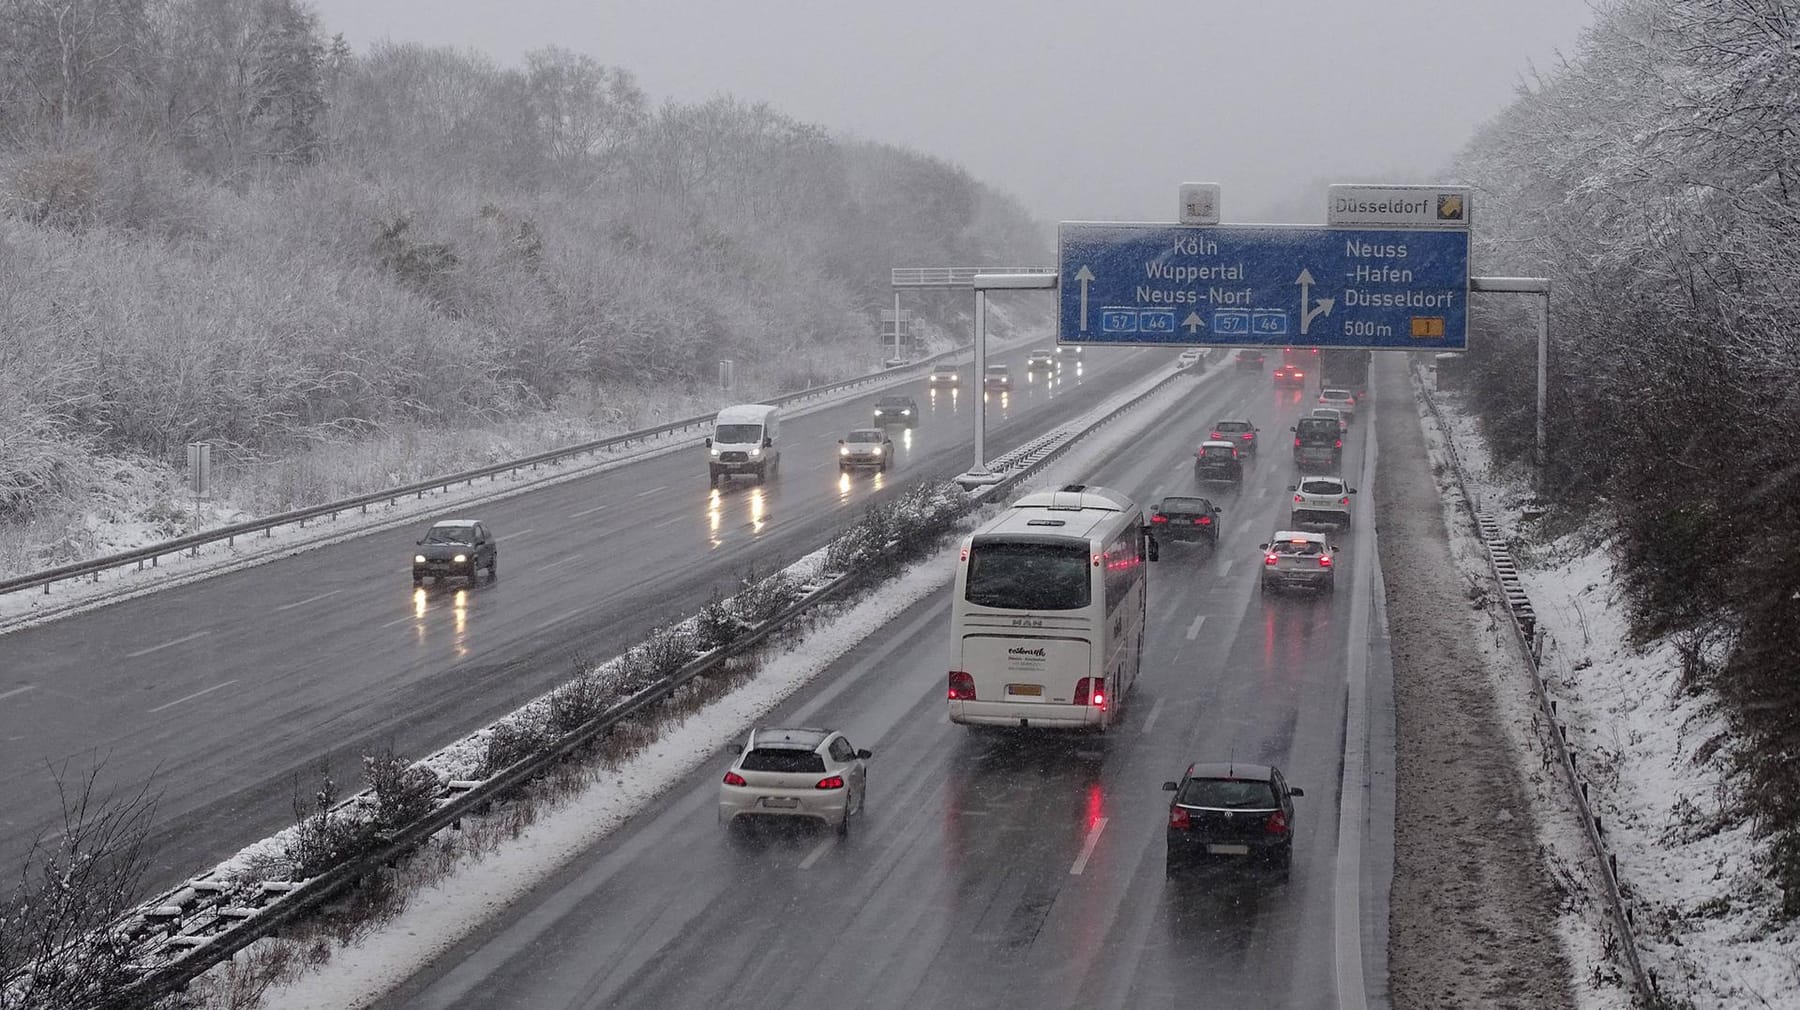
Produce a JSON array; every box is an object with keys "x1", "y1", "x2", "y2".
[{"x1": 0, "y1": 0, "x2": 1049, "y2": 547}]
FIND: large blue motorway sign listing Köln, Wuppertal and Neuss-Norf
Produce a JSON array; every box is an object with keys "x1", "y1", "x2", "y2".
[{"x1": 1057, "y1": 221, "x2": 1469, "y2": 351}]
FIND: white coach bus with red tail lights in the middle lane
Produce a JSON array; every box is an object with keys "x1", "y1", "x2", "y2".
[{"x1": 950, "y1": 484, "x2": 1157, "y2": 731}]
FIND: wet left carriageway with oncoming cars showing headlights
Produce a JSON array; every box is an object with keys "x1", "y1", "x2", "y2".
[{"x1": 0, "y1": 342, "x2": 1174, "y2": 888}]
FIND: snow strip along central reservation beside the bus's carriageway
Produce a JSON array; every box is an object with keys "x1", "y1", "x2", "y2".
[{"x1": 209, "y1": 358, "x2": 1193, "y2": 1010}]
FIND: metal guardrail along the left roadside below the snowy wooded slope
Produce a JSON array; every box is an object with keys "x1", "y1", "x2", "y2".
[{"x1": 0, "y1": 338, "x2": 1029, "y2": 596}]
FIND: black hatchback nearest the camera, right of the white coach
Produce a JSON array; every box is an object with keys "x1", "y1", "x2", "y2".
[{"x1": 1163, "y1": 762, "x2": 1305, "y2": 880}]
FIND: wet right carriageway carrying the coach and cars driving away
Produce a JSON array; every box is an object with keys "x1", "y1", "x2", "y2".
[{"x1": 378, "y1": 358, "x2": 1408, "y2": 1010}]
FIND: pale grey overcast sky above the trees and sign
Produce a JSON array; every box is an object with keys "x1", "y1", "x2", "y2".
[{"x1": 315, "y1": 0, "x2": 1591, "y2": 223}]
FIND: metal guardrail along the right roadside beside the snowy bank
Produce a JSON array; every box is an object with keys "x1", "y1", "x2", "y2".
[{"x1": 1413, "y1": 361, "x2": 1656, "y2": 1005}]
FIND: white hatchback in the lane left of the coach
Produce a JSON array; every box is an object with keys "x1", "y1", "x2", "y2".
[{"x1": 718, "y1": 727, "x2": 875, "y2": 835}]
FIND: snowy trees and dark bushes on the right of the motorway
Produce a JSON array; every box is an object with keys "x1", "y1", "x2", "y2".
[{"x1": 1460, "y1": 0, "x2": 1800, "y2": 916}]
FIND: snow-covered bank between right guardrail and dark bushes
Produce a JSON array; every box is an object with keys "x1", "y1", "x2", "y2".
[{"x1": 1436, "y1": 378, "x2": 1800, "y2": 1010}]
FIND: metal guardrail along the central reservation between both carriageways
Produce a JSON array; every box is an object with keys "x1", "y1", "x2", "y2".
[{"x1": 66, "y1": 349, "x2": 1226, "y2": 1010}]
